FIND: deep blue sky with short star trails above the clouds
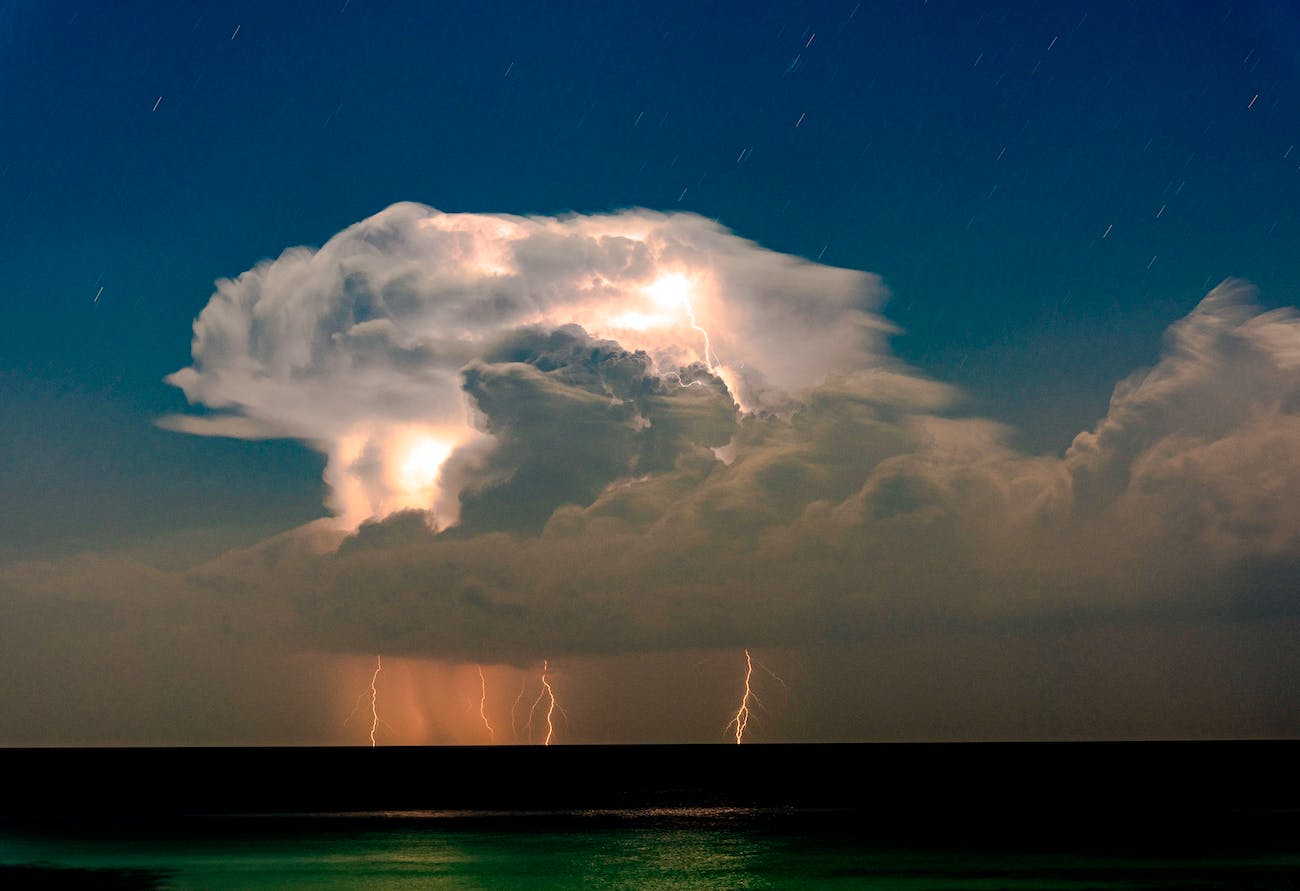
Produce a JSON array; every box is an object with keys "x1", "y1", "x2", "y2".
[{"x1": 0, "y1": 0, "x2": 1300, "y2": 557}]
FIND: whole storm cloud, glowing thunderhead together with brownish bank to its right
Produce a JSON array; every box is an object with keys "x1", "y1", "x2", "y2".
[{"x1": 147, "y1": 204, "x2": 1300, "y2": 659}]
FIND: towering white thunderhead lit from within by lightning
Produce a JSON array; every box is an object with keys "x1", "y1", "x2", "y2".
[{"x1": 163, "y1": 204, "x2": 889, "y2": 527}]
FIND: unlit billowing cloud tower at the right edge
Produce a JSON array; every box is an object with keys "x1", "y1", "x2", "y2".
[{"x1": 1066, "y1": 281, "x2": 1300, "y2": 559}]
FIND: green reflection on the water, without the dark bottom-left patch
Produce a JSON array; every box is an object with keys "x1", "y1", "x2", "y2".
[{"x1": 0, "y1": 817, "x2": 1300, "y2": 891}]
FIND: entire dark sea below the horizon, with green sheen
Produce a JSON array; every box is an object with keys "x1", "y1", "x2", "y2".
[{"x1": 0, "y1": 743, "x2": 1300, "y2": 891}]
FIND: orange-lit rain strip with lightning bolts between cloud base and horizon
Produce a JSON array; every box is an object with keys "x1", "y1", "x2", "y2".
[{"x1": 325, "y1": 645, "x2": 797, "y2": 748}]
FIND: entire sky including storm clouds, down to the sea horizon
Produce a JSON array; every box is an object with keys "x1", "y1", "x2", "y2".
[{"x1": 0, "y1": 0, "x2": 1300, "y2": 744}]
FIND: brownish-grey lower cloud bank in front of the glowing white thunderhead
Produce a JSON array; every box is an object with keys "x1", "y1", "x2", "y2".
[{"x1": 253, "y1": 282, "x2": 1300, "y2": 659}]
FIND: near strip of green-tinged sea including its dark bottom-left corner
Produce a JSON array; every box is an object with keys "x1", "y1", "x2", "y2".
[{"x1": 0, "y1": 808, "x2": 1300, "y2": 891}]
